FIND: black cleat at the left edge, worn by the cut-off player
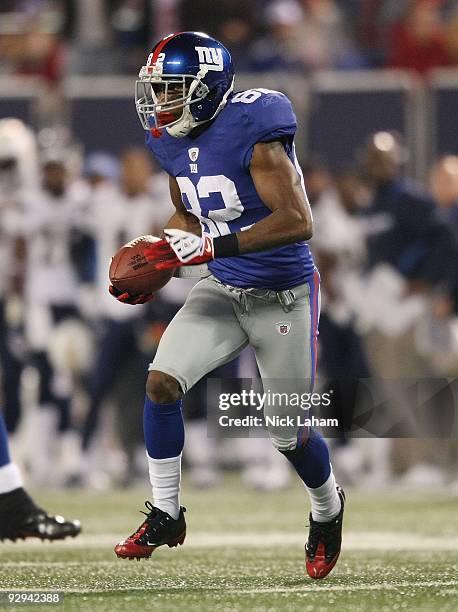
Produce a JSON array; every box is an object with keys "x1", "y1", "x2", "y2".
[{"x1": 0, "y1": 487, "x2": 81, "y2": 542}]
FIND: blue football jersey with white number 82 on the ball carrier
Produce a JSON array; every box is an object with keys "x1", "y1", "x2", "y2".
[{"x1": 146, "y1": 89, "x2": 314, "y2": 290}]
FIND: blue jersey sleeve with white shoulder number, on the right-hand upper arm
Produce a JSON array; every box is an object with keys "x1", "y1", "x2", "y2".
[{"x1": 236, "y1": 89, "x2": 297, "y2": 169}]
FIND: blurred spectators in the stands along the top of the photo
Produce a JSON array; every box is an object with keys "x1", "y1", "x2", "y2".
[{"x1": 0, "y1": 0, "x2": 458, "y2": 85}]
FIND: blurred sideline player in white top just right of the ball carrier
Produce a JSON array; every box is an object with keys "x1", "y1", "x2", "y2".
[{"x1": 303, "y1": 158, "x2": 370, "y2": 483}]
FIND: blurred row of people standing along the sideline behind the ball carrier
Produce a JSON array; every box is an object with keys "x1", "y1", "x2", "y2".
[{"x1": 0, "y1": 118, "x2": 458, "y2": 489}]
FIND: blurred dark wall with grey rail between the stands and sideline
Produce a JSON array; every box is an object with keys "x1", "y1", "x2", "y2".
[{"x1": 0, "y1": 69, "x2": 458, "y2": 180}]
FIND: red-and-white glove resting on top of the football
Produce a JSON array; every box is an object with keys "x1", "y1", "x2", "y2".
[{"x1": 144, "y1": 229, "x2": 214, "y2": 270}]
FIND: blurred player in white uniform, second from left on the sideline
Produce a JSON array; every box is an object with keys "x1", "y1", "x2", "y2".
[{"x1": 24, "y1": 143, "x2": 84, "y2": 486}]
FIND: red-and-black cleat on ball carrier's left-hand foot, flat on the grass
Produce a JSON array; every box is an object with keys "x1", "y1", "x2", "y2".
[{"x1": 114, "y1": 501, "x2": 186, "y2": 561}]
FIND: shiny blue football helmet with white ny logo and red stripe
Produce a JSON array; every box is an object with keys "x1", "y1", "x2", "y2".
[{"x1": 135, "y1": 32, "x2": 234, "y2": 138}]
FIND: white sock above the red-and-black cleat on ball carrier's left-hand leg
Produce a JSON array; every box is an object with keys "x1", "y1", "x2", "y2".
[{"x1": 146, "y1": 453, "x2": 181, "y2": 520}]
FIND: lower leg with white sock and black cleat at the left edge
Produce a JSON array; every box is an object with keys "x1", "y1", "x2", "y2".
[{"x1": 0, "y1": 411, "x2": 81, "y2": 541}]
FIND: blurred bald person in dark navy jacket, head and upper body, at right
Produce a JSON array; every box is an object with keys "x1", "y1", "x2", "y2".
[{"x1": 364, "y1": 132, "x2": 454, "y2": 292}]
